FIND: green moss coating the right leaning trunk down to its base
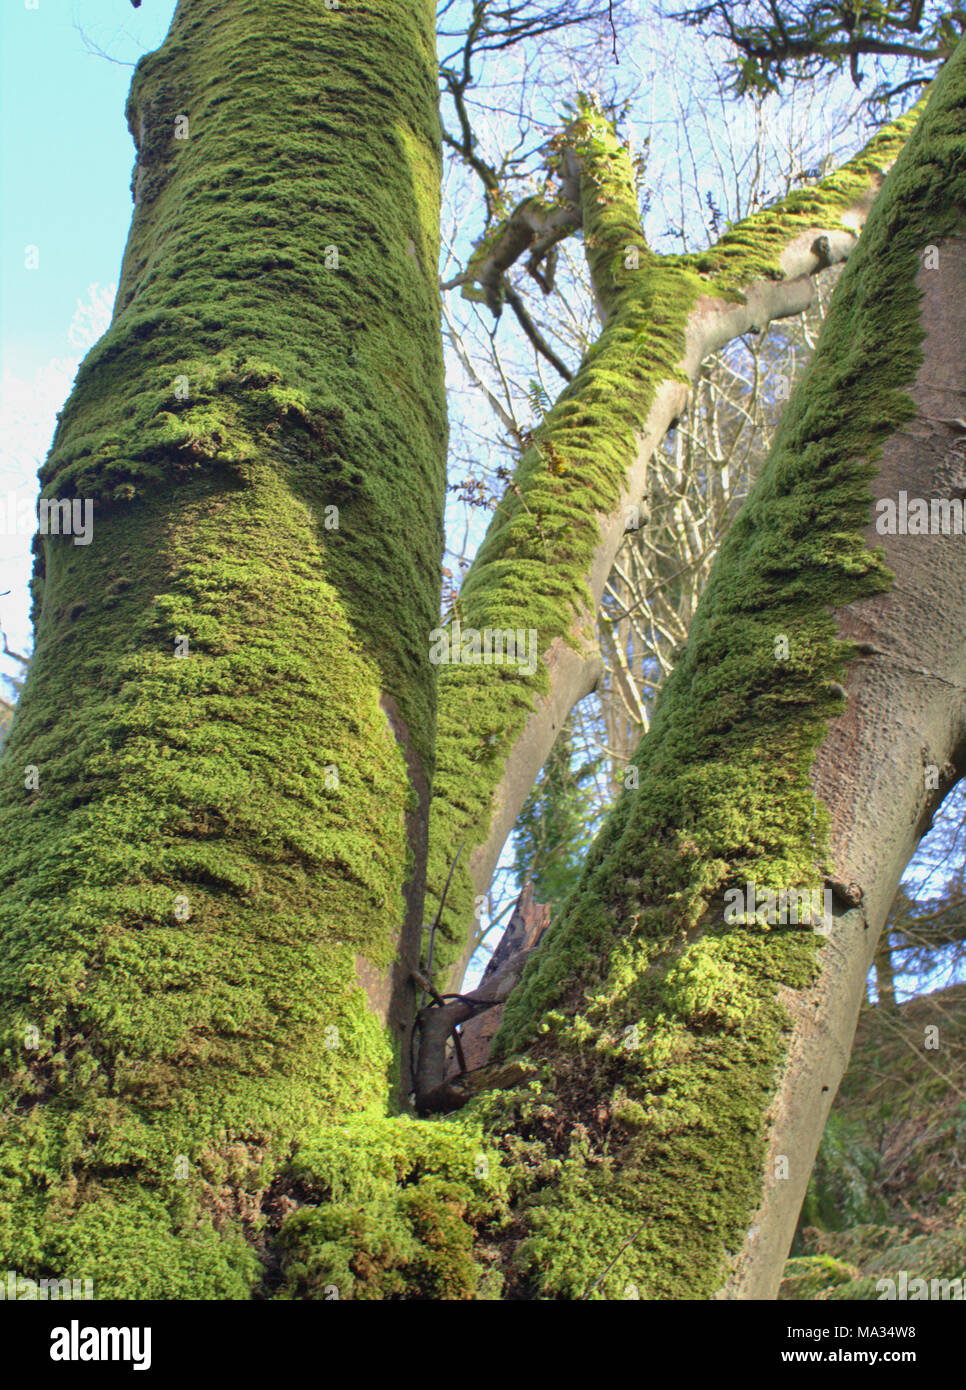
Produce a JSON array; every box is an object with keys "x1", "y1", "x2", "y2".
[{"x1": 258, "y1": 50, "x2": 966, "y2": 1300}]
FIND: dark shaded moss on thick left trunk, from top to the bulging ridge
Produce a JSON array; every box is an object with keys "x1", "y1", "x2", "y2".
[{"x1": 51, "y1": 0, "x2": 445, "y2": 766}]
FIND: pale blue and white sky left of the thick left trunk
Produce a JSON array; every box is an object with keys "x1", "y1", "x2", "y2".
[{"x1": 0, "y1": 0, "x2": 174, "y2": 670}]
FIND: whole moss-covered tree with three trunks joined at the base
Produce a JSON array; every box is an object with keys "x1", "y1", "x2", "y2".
[{"x1": 0, "y1": 0, "x2": 966, "y2": 1298}]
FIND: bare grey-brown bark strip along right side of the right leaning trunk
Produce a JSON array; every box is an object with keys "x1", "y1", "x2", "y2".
[{"x1": 727, "y1": 222, "x2": 966, "y2": 1298}]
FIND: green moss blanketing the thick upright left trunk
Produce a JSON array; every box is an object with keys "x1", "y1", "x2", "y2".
[{"x1": 0, "y1": 0, "x2": 445, "y2": 1297}]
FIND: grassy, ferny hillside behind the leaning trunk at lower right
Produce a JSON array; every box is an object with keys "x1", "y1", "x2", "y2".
[{"x1": 781, "y1": 986, "x2": 966, "y2": 1298}]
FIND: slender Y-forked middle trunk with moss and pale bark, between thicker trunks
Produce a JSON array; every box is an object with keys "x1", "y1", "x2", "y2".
[{"x1": 428, "y1": 95, "x2": 916, "y2": 989}]
